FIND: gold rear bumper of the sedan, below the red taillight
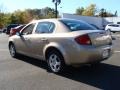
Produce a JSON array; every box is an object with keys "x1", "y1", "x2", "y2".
[{"x1": 66, "y1": 45, "x2": 113, "y2": 64}]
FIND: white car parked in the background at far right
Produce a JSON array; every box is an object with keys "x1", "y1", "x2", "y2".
[{"x1": 105, "y1": 24, "x2": 120, "y2": 33}]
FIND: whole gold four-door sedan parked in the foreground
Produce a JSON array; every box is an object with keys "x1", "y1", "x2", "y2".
[{"x1": 8, "y1": 19, "x2": 113, "y2": 73}]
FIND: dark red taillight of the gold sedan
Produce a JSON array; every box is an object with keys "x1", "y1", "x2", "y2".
[{"x1": 75, "y1": 34, "x2": 92, "y2": 45}]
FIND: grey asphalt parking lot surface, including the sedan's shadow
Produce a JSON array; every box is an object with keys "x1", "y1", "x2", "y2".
[{"x1": 0, "y1": 34, "x2": 120, "y2": 90}]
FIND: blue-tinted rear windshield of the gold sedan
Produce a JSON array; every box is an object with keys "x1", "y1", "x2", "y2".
[{"x1": 60, "y1": 20, "x2": 96, "y2": 31}]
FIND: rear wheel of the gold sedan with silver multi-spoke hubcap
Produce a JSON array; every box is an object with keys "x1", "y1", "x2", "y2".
[{"x1": 47, "y1": 50, "x2": 65, "y2": 73}]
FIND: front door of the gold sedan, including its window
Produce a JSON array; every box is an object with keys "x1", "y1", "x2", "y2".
[{"x1": 16, "y1": 24, "x2": 35, "y2": 55}]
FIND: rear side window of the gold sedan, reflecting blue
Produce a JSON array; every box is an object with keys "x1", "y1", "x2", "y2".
[{"x1": 35, "y1": 22, "x2": 55, "y2": 34}]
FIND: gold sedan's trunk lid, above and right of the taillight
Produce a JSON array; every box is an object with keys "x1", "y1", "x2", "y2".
[{"x1": 72, "y1": 30, "x2": 112, "y2": 46}]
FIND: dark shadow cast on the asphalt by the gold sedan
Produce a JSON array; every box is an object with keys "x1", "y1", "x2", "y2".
[{"x1": 17, "y1": 56, "x2": 120, "y2": 90}]
